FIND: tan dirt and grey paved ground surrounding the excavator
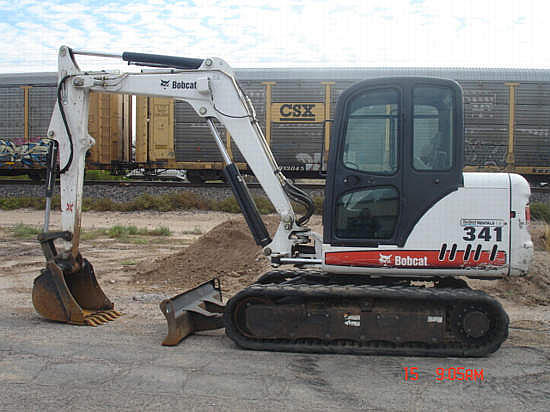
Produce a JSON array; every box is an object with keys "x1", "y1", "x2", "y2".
[{"x1": 0, "y1": 210, "x2": 550, "y2": 412}]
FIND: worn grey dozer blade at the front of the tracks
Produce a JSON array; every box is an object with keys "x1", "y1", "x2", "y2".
[{"x1": 160, "y1": 278, "x2": 224, "y2": 346}]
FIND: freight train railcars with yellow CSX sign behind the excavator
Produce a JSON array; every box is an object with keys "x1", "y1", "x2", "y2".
[{"x1": 0, "y1": 68, "x2": 550, "y2": 181}]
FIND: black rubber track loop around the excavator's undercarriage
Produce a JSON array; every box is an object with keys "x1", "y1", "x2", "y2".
[{"x1": 224, "y1": 271, "x2": 509, "y2": 357}]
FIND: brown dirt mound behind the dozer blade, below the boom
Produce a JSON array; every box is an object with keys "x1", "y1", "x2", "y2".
[{"x1": 133, "y1": 216, "x2": 278, "y2": 296}]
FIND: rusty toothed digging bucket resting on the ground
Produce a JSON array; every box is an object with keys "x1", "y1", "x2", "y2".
[{"x1": 32, "y1": 259, "x2": 121, "y2": 326}]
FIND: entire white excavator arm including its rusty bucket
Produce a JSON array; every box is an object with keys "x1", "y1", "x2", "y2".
[{"x1": 33, "y1": 46, "x2": 322, "y2": 332}]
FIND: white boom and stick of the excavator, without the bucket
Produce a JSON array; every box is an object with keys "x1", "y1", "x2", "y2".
[{"x1": 48, "y1": 46, "x2": 322, "y2": 258}]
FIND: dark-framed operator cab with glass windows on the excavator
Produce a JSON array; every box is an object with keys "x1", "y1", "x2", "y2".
[{"x1": 324, "y1": 77, "x2": 464, "y2": 247}]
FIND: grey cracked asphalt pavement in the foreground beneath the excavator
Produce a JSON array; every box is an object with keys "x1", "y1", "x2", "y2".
[{"x1": 0, "y1": 307, "x2": 550, "y2": 411}]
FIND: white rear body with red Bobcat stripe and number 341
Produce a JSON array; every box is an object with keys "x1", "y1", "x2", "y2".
[{"x1": 322, "y1": 173, "x2": 533, "y2": 278}]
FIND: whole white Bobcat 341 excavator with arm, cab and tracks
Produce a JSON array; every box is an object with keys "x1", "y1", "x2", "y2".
[{"x1": 33, "y1": 46, "x2": 533, "y2": 356}]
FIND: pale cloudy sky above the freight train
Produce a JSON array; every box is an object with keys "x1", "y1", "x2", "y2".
[{"x1": 0, "y1": 0, "x2": 550, "y2": 73}]
